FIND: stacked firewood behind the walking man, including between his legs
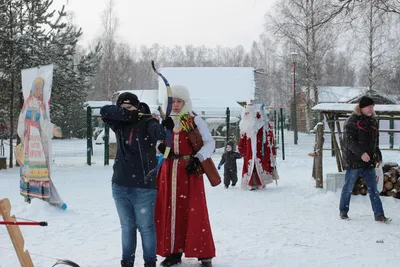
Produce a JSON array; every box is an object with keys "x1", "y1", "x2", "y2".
[{"x1": 352, "y1": 163, "x2": 400, "y2": 198}]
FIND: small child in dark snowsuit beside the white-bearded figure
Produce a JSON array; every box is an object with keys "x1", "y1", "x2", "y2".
[{"x1": 218, "y1": 142, "x2": 241, "y2": 188}]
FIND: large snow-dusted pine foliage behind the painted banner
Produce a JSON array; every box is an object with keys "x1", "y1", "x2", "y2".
[{"x1": 0, "y1": 0, "x2": 100, "y2": 167}]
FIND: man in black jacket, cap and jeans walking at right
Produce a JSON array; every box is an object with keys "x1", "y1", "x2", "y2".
[{"x1": 339, "y1": 96, "x2": 389, "y2": 222}]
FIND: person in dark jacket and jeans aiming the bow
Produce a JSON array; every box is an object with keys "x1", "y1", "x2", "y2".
[{"x1": 100, "y1": 93, "x2": 174, "y2": 267}]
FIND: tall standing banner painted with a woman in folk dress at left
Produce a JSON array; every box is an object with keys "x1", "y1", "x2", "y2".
[{"x1": 15, "y1": 65, "x2": 66, "y2": 209}]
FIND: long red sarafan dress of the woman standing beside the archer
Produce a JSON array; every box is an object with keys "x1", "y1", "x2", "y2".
[{"x1": 155, "y1": 127, "x2": 215, "y2": 258}]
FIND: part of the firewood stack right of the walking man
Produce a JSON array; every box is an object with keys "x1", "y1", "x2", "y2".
[{"x1": 380, "y1": 164, "x2": 400, "y2": 198}]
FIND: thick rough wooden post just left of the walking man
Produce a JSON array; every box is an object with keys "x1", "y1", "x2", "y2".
[{"x1": 313, "y1": 122, "x2": 325, "y2": 188}]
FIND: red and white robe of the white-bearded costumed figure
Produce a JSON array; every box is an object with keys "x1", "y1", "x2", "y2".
[{"x1": 238, "y1": 123, "x2": 279, "y2": 189}]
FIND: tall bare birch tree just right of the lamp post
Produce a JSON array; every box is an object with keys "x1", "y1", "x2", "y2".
[{"x1": 267, "y1": 0, "x2": 339, "y2": 131}]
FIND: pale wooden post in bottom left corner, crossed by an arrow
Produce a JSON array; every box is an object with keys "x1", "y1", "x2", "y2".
[{"x1": 0, "y1": 198, "x2": 34, "y2": 267}]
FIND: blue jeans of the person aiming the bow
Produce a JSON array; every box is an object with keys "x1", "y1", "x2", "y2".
[{"x1": 112, "y1": 184, "x2": 157, "y2": 263}]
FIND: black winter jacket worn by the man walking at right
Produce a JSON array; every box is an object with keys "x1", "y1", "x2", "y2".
[{"x1": 343, "y1": 105, "x2": 382, "y2": 169}]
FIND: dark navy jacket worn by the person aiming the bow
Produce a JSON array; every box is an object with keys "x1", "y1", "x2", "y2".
[{"x1": 100, "y1": 105, "x2": 165, "y2": 189}]
